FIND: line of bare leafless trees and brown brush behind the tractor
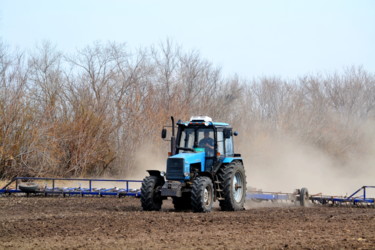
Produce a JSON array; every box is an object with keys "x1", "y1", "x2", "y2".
[{"x1": 0, "y1": 41, "x2": 375, "y2": 178}]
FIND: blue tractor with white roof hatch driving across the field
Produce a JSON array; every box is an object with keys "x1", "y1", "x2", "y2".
[{"x1": 141, "y1": 116, "x2": 246, "y2": 212}]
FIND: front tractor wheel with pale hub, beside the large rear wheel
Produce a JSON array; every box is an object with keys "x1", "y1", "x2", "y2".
[{"x1": 191, "y1": 176, "x2": 214, "y2": 213}]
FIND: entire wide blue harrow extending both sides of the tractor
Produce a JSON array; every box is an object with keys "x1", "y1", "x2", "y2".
[{"x1": 0, "y1": 177, "x2": 375, "y2": 208}]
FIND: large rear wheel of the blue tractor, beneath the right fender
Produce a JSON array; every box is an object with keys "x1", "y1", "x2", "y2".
[{"x1": 218, "y1": 162, "x2": 246, "y2": 211}]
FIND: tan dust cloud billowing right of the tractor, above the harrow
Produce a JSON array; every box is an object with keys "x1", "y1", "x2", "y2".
[{"x1": 238, "y1": 122, "x2": 375, "y2": 197}]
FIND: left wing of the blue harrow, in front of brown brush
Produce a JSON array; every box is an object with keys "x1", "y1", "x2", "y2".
[{"x1": 0, "y1": 177, "x2": 142, "y2": 197}]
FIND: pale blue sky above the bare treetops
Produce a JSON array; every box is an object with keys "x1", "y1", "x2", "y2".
[{"x1": 0, "y1": 0, "x2": 375, "y2": 79}]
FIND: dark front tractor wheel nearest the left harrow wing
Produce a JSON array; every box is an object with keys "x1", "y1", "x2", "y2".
[{"x1": 141, "y1": 176, "x2": 163, "y2": 211}]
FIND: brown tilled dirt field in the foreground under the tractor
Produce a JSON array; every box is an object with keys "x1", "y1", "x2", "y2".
[{"x1": 0, "y1": 197, "x2": 375, "y2": 249}]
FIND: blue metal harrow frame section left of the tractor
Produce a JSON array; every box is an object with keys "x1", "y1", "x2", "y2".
[{"x1": 0, "y1": 177, "x2": 142, "y2": 197}]
